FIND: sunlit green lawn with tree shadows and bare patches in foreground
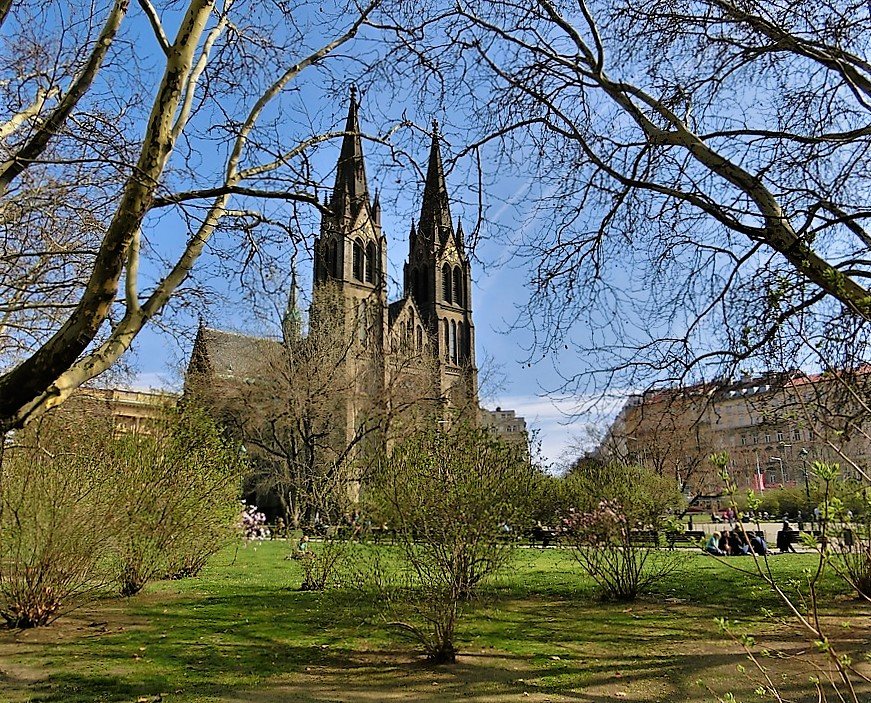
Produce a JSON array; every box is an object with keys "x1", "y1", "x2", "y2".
[{"x1": 0, "y1": 542, "x2": 871, "y2": 703}]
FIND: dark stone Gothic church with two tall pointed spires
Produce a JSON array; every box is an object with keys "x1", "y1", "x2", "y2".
[{"x1": 185, "y1": 89, "x2": 494, "y2": 524}]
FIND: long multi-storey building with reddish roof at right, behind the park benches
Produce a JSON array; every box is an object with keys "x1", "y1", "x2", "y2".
[{"x1": 598, "y1": 370, "x2": 871, "y2": 502}]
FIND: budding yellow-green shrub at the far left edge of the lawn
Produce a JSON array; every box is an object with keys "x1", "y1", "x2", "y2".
[{"x1": 0, "y1": 414, "x2": 115, "y2": 628}]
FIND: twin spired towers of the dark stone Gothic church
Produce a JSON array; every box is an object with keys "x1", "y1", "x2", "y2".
[{"x1": 314, "y1": 89, "x2": 478, "y2": 413}]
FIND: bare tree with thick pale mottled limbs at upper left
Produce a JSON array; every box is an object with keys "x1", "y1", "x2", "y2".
[{"x1": 0, "y1": 0, "x2": 390, "y2": 431}]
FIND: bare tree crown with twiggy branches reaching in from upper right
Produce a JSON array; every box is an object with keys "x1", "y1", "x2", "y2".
[{"x1": 380, "y1": 0, "x2": 871, "y2": 394}]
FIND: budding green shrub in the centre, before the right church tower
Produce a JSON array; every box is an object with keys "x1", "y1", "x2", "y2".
[{"x1": 376, "y1": 425, "x2": 536, "y2": 663}]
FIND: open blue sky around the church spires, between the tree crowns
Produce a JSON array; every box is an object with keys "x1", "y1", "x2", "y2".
[{"x1": 68, "y1": 2, "x2": 623, "y2": 470}]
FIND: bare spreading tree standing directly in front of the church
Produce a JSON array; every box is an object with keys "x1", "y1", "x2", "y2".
[{"x1": 189, "y1": 284, "x2": 436, "y2": 526}]
